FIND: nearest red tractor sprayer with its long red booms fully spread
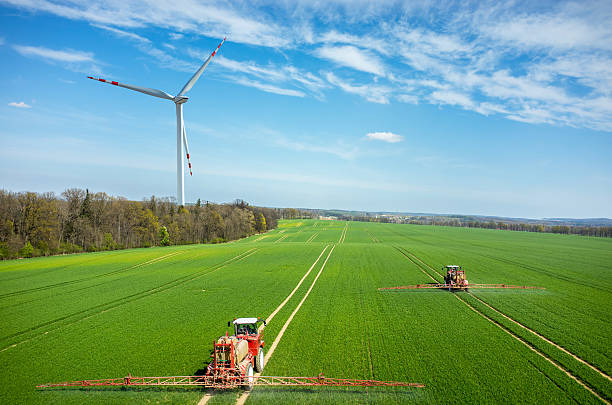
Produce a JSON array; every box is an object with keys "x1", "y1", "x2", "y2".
[{"x1": 37, "y1": 318, "x2": 425, "y2": 389}]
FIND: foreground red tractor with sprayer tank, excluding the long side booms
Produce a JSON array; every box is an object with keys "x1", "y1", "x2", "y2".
[{"x1": 206, "y1": 318, "x2": 266, "y2": 388}]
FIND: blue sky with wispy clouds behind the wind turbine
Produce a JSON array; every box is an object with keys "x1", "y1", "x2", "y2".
[{"x1": 0, "y1": 0, "x2": 612, "y2": 218}]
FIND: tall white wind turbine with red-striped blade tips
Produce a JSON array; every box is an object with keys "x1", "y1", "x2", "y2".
[{"x1": 87, "y1": 38, "x2": 225, "y2": 205}]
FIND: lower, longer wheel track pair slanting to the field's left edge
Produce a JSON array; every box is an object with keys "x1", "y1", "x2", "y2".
[{"x1": 0, "y1": 248, "x2": 257, "y2": 353}]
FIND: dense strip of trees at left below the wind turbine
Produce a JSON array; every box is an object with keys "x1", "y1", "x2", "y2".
[{"x1": 0, "y1": 188, "x2": 283, "y2": 259}]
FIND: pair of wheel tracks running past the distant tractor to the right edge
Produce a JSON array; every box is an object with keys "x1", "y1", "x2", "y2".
[{"x1": 395, "y1": 246, "x2": 612, "y2": 403}]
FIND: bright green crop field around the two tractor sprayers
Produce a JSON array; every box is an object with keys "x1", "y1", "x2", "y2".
[{"x1": 0, "y1": 219, "x2": 612, "y2": 404}]
